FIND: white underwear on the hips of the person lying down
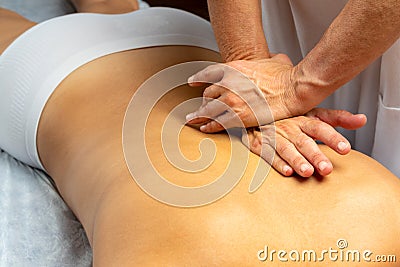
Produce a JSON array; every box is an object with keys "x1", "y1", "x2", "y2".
[{"x1": 0, "y1": 7, "x2": 218, "y2": 172}]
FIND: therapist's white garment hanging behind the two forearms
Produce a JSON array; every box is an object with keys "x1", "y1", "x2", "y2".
[{"x1": 262, "y1": 0, "x2": 400, "y2": 177}]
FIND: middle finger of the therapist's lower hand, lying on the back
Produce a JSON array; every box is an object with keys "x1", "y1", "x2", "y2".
[{"x1": 291, "y1": 133, "x2": 333, "y2": 176}]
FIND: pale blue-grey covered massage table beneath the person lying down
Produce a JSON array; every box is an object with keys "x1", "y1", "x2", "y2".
[{"x1": 0, "y1": 0, "x2": 148, "y2": 267}]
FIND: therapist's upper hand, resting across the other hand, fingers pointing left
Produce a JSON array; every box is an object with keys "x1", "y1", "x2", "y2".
[{"x1": 186, "y1": 54, "x2": 322, "y2": 133}]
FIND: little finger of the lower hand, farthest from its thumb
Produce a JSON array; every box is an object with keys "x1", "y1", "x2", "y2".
[{"x1": 242, "y1": 130, "x2": 293, "y2": 176}]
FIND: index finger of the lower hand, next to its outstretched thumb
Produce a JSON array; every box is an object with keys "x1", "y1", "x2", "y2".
[{"x1": 301, "y1": 120, "x2": 351, "y2": 155}]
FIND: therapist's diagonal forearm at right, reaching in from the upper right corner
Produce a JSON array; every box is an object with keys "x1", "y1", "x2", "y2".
[{"x1": 296, "y1": 0, "x2": 400, "y2": 99}]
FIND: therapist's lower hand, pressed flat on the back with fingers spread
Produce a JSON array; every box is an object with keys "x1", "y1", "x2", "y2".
[{"x1": 242, "y1": 108, "x2": 366, "y2": 177}]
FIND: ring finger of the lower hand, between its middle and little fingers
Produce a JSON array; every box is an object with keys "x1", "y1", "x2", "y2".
[{"x1": 275, "y1": 134, "x2": 314, "y2": 177}]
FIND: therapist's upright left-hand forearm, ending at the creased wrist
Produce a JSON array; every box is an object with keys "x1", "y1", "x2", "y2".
[{"x1": 208, "y1": 0, "x2": 269, "y2": 61}]
